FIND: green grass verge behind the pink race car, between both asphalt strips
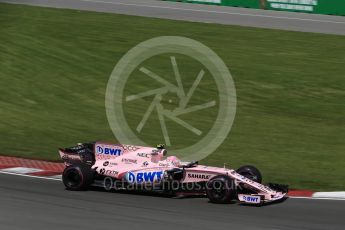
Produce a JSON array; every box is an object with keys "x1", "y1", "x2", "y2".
[{"x1": 0, "y1": 4, "x2": 345, "y2": 190}]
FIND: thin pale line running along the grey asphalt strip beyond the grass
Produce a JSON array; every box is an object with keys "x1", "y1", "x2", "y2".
[{"x1": 78, "y1": 0, "x2": 345, "y2": 24}]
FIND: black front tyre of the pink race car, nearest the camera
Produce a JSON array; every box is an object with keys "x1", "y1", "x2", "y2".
[{"x1": 206, "y1": 175, "x2": 236, "y2": 204}]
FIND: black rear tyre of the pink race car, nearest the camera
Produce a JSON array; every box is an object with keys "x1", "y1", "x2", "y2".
[{"x1": 62, "y1": 165, "x2": 94, "y2": 191}]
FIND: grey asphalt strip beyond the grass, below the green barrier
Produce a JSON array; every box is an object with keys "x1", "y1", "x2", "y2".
[{"x1": 0, "y1": 0, "x2": 345, "y2": 35}]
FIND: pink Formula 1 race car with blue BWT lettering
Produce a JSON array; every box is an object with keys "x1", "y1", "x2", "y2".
[{"x1": 59, "y1": 142, "x2": 288, "y2": 205}]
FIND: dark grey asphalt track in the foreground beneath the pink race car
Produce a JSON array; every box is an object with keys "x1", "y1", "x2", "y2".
[{"x1": 0, "y1": 174, "x2": 345, "y2": 230}]
